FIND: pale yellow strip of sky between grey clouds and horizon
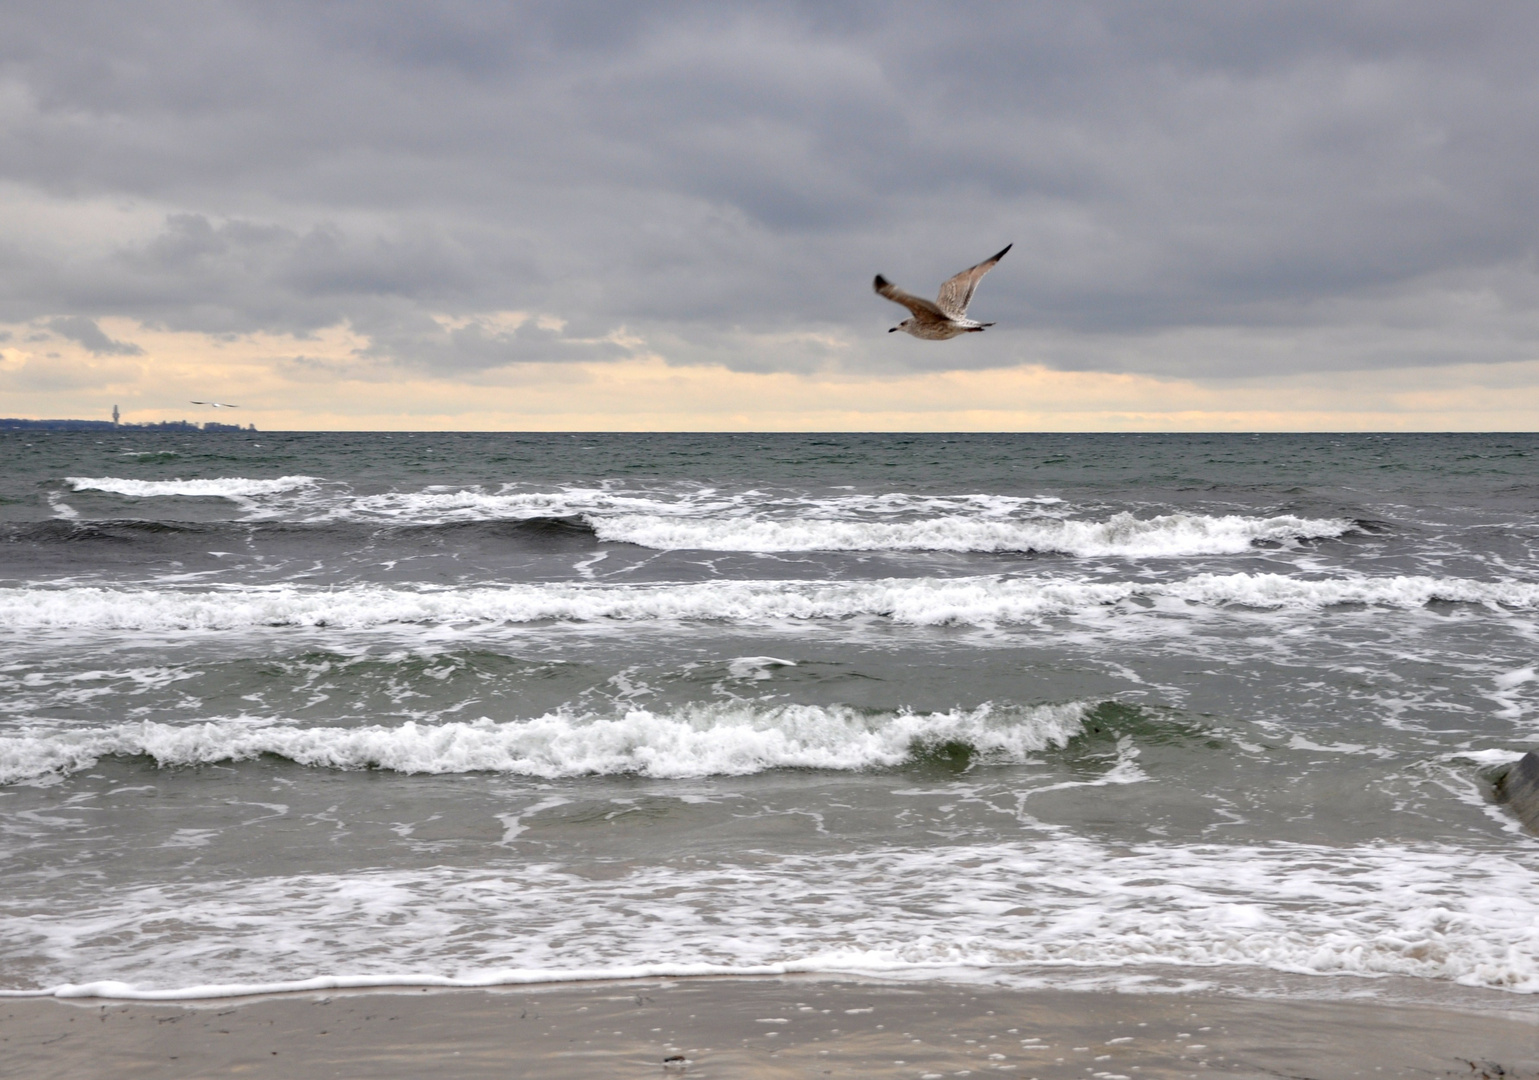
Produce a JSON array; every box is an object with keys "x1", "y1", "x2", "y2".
[{"x1": 0, "y1": 315, "x2": 1539, "y2": 431}]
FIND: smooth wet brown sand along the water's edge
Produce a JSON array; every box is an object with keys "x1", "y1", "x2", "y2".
[{"x1": 0, "y1": 977, "x2": 1539, "y2": 1080}]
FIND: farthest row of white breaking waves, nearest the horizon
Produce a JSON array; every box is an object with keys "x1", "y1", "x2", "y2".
[{"x1": 42, "y1": 475, "x2": 1357, "y2": 558}]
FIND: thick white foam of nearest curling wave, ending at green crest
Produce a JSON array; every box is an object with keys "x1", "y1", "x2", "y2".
[{"x1": 0, "y1": 702, "x2": 1087, "y2": 783}]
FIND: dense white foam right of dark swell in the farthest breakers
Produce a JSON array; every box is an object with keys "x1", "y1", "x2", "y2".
[{"x1": 589, "y1": 512, "x2": 1353, "y2": 558}]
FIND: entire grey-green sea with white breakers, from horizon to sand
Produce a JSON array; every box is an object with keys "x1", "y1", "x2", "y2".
[{"x1": 0, "y1": 428, "x2": 1539, "y2": 1006}]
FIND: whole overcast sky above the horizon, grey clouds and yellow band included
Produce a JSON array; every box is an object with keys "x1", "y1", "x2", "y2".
[{"x1": 0, "y1": 0, "x2": 1539, "y2": 428}]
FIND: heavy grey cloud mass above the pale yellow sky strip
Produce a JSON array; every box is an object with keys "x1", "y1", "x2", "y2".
[{"x1": 0, "y1": 0, "x2": 1539, "y2": 375}]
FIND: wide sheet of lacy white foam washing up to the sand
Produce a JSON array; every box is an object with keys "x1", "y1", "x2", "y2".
[{"x1": 0, "y1": 834, "x2": 1539, "y2": 998}]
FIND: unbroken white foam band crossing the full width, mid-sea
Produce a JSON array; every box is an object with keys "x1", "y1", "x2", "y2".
[{"x1": 0, "y1": 574, "x2": 1539, "y2": 632}]
